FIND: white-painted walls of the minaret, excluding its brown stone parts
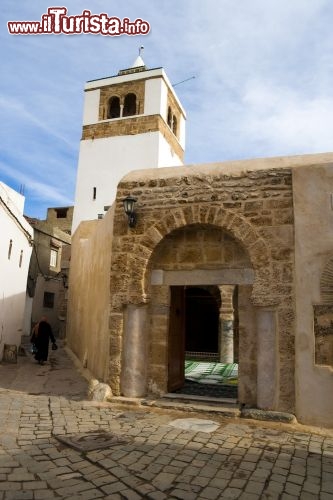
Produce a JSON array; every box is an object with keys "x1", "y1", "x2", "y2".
[{"x1": 72, "y1": 61, "x2": 185, "y2": 233}]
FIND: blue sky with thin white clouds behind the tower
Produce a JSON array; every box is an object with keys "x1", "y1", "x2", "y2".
[{"x1": 0, "y1": 0, "x2": 333, "y2": 219}]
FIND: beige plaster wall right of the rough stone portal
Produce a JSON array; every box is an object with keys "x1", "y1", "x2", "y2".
[{"x1": 293, "y1": 163, "x2": 333, "y2": 426}]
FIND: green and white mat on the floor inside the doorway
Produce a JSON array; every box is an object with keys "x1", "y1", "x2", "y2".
[{"x1": 185, "y1": 360, "x2": 238, "y2": 385}]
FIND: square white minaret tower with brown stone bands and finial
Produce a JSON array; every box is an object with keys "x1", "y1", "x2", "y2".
[{"x1": 72, "y1": 47, "x2": 186, "y2": 233}]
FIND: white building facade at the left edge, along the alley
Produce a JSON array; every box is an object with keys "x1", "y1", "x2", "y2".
[{"x1": 0, "y1": 182, "x2": 33, "y2": 360}]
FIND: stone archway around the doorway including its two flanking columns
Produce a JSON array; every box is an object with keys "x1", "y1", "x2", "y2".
[{"x1": 110, "y1": 204, "x2": 290, "y2": 408}]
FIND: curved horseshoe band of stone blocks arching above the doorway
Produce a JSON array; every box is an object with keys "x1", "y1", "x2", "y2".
[{"x1": 111, "y1": 204, "x2": 277, "y2": 311}]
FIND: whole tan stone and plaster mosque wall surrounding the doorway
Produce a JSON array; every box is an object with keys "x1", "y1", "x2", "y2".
[{"x1": 65, "y1": 154, "x2": 333, "y2": 426}]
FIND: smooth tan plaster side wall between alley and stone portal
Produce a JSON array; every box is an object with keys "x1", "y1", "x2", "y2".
[{"x1": 67, "y1": 208, "x2": 113, "y2": 381}]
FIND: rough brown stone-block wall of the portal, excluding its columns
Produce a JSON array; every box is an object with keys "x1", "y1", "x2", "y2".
[{"x1": 110, "y1": 160, "x2": 295, "y2": 410}]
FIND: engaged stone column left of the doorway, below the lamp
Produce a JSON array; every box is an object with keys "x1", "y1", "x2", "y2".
[{"x1": 120, "y1": 304, "x2": 148, "y2": 398}]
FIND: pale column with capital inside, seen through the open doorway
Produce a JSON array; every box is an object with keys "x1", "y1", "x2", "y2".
[{"x1": 219, "y1": 285, "x2": 235, "y2": 363}]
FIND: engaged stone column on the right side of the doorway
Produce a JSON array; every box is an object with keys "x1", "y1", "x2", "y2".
[{"x1": 256, "y1": 307, "x2": 278, "y2": 410}]
